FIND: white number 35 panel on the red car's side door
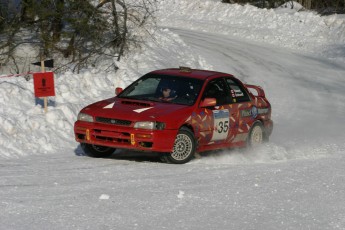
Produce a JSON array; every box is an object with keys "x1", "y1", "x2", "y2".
[{"x1": 211, "y1": 109, "x2": 230, "y2": 141}]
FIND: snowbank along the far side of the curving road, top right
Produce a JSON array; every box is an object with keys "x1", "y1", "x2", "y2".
[{"x1": 160, "y1": 0, "x2": 345, "y2": 61}]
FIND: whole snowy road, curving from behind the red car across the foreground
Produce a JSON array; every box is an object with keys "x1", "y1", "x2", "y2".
[{"x1": 0, "y1": 29, "x2": 345, "y2": 229}]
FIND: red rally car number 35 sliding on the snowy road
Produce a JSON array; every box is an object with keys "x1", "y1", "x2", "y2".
[{"x1": 74, "y1": 67, "x2": 273, "y2": 164}]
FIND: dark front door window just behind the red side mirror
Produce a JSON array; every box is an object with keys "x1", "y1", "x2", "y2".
[{"x1": 202, "y1": 78, "x2": 231, "y2": 105}]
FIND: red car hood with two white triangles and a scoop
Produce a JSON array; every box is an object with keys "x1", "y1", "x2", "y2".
[{"x1": 81, "y1": 97, "x2": 193, "y2": 122}]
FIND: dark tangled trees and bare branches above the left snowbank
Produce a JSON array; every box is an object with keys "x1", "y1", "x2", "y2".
[{"x1": 0, "y1": 0, "x2": 156, "y2": 73}]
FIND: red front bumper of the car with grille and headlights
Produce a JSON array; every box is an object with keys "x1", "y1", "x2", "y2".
[{"x1": 74, "y1": 121, "x2": 178, "y2": 152}]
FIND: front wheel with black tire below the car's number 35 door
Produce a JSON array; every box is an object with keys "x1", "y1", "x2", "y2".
[{"x1": 162, "y1": 127, "x2": 196, "y2": 164}]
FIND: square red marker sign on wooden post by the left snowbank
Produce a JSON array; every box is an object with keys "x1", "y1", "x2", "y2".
[{"x1": 33, "y1": 72, "x2": 55, "y2": 97}]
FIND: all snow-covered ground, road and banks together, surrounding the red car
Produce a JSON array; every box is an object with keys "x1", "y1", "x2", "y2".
[{"x1": 0, "y1": 0, "x2": 345, "y2": 229}]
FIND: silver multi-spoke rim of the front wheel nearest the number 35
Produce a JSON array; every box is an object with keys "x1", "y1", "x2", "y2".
[{"x1": 171, "y1": 134, "x2": 193, "y2": 161}]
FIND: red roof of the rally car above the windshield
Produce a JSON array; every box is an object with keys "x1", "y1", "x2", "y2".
[{"x1": 150, "y1": 67, "x2": 233, "y2": 80}]
